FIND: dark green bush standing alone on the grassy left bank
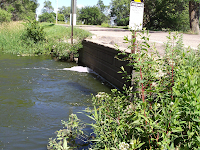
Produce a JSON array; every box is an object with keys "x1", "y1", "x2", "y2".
[{"x1": 22, "y1": 20, "x2": 45, "y2": 43}]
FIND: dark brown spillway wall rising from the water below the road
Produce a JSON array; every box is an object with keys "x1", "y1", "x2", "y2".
[{"x1": 78, "y1": 40, "x2": 132, "y2": 90}]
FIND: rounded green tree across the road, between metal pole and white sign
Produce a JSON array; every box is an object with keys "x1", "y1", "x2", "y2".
[{"x1": 78, "y1": 6, "x2": 103, "y2": 25}]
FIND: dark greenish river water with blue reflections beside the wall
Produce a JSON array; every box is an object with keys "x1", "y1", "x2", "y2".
[{"x1": 0, "y1": 54, "x2": 110, "y2": 150}]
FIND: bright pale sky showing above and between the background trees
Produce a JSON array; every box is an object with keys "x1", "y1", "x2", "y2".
[{"x1": 36, "y1": 0, "x2": 111, "y2": 16}]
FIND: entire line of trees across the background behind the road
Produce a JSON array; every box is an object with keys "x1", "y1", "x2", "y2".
[{"x1": 0, "y1": 0, "x2": 200, "y2": 33}]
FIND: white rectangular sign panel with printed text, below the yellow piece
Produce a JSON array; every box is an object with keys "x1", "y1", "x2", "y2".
[{"x1": 129, "y1": 1, "x2": 144, "y2": 30}]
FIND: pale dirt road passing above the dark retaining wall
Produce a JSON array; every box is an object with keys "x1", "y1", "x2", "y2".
[{"x1": 61, "y1": 25, "x2": 200, "y2": 54}]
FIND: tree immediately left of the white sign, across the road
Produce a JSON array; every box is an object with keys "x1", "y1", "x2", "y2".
[{"x1": 110, "y1": 0, "x2": 131, "y2": 26}]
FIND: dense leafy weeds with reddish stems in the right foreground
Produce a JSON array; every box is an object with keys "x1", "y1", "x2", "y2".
[{"x1": 48, "y1": 33, "x2": 200, "y2": 150}]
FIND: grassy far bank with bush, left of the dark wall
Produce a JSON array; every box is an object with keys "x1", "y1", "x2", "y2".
[{"x1": 0, "y1": 21, "x2": 90, "y2": 59}]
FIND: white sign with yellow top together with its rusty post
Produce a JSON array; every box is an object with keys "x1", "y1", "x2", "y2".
[{"x1": 129, "y1": 0, "x2": 144, "y2": 53}]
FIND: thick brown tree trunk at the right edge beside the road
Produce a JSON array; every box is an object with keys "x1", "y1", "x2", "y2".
[{"x1": 189, "y1": 0, "x2": 200, "y2": 34}]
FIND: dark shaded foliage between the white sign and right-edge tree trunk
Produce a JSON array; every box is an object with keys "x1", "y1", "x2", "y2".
[{"x1": 144, "y1": 0, "x2": 190, "y2": 31}]
